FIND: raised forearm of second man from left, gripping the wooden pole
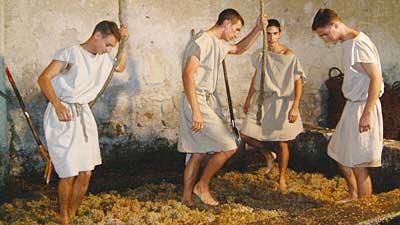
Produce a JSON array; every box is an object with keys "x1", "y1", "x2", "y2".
[{"x1": 229, "y1": 16, "x2": 266, "y2": 55}]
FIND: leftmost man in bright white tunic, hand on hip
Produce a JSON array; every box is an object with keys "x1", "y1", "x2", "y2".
[{"x1": 38, "y1": 21, "x2": 128, "y2": 224}]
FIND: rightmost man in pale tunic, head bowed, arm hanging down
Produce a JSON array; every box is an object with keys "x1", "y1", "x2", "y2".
[{"x1": 312, "y1": 9, "x2": 384, "y2": 203}]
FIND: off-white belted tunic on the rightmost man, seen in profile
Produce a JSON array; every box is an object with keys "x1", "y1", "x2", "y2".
[{"x1": 328, "y1": 32, "x2": 384, "y2": 167}]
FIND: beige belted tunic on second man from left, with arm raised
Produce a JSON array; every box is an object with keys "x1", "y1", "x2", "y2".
[{"x1": 178, "y1": 32, "x2": 236, "y2": 153}]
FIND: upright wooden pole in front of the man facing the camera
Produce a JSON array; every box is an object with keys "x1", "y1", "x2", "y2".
[{"x1": 256, "y1": 0, "x2": 268, "y2": 125}]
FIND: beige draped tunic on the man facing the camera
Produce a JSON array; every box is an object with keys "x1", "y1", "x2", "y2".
[{"x1": 241, "y1": 51, "x2": 306, "y2": 141}]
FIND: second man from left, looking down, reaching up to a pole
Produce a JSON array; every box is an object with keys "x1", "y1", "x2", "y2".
[{"x1": 178, "y1": 9, "x2": 263, "y2": 206}]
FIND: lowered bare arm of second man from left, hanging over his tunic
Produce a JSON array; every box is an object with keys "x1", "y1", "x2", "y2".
[{"x1": 182, "y1": 48, "x2": 204, "y2": 132}]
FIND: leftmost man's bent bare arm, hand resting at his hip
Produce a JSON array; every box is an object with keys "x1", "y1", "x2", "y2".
[{"x1": 38, "y1": 60, "x2": 72, "y2": 121}]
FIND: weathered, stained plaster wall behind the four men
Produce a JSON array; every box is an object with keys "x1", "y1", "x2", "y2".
[{"x1": 0, "y1": 0, "x2": 400, "y2": 174}]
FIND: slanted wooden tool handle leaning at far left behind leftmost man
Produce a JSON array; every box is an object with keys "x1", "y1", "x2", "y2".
[{"x1": 6, "y1": 67, "x2": 53, "y2": 184}]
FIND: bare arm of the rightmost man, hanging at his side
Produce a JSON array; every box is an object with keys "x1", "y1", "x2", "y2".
[{"x1": 359, "y1": 63, "x2": 382, "y2": 133}]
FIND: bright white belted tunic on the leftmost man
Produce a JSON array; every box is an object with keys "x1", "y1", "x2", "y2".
[{"x1": 43, "y1": 45, "x2": 114, "y2": 178}]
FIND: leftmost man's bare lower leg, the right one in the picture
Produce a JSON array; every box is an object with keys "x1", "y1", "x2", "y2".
[{"x1": 69, "y1": 171, "x2": 92, "y2": 217}]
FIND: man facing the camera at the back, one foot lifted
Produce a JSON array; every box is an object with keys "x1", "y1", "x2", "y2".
[{"x1": 241, "y1": 19, "x2": 305, "y2": 190}]
